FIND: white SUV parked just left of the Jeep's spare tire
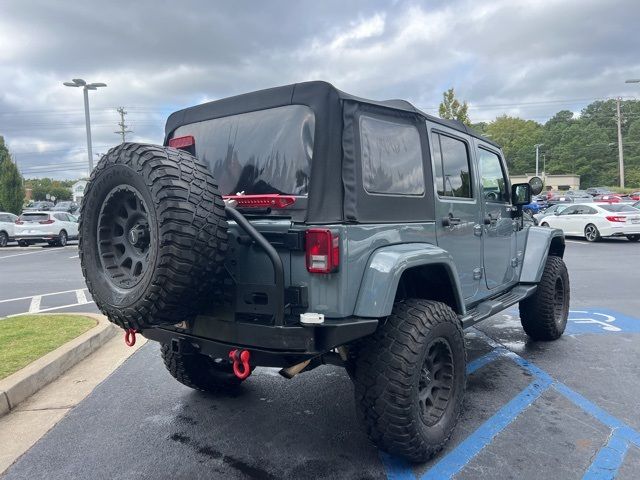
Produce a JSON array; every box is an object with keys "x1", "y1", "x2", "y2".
[{"x1": 15, "y1": 212, "x2": 78, "y2": 247}]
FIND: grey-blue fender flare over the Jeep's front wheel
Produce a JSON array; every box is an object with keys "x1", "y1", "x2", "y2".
[{"x1": 520, "y1": 227, "x2": 565, "y2": 283}]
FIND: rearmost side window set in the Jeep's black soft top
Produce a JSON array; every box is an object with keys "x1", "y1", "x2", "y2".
[{"x1": 360, "y1": 115, "x2": 424, "y2": 195}]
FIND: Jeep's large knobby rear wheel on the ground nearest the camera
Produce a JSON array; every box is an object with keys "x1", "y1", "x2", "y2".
[{"x1": 353, "y1": 299, "x2": 466, "y2": 462}]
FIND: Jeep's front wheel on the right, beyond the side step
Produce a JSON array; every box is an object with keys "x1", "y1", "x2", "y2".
[{"x1": 520, "y1": 255, "x2": 570, "y2": 340}]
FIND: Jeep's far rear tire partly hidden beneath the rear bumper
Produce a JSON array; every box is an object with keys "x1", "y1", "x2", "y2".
[{"x1": 160, "y1": 344, "x2": 243, "y2": 392}]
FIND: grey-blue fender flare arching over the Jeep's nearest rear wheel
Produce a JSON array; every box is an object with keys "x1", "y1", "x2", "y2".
[{"x1": 354, "y1": 243, "x2": 466, "y2": 318}]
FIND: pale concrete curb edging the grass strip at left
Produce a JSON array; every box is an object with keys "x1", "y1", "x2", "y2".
[{"x1": 0, "y1": 312, "x2": 119, "y2": 417}]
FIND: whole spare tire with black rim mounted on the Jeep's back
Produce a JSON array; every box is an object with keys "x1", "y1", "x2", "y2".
[{"x1": 78, "y1": 143, "x2": 227, "y2": 330}]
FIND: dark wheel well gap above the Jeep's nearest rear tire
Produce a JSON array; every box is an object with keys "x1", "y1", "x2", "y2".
[{"x1": 395, "y1": 265, "x2": 462, "y2": 313}]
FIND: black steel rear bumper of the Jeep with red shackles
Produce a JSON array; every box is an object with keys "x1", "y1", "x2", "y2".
[{"x1": 141, "y1": 317, "x2": 378, "y2": 367}]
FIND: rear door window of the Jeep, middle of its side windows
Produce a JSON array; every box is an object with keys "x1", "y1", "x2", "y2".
[{"x1": 432, "y1": 133, "x2": 473, "y2": 198}]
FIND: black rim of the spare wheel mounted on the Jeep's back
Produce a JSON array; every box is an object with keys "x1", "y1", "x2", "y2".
[{"x1": 98, "y1": 185, "x2": 152, "y2": 288}]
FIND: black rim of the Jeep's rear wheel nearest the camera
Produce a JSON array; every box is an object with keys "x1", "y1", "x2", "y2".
[{"x1": 418, "y1": 338, "x2": 454, "y2": 427}]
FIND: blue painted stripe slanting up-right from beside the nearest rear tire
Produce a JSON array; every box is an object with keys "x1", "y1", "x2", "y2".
[{"x1": 421, "y1": 379, "x2": 551, "y2": 480}]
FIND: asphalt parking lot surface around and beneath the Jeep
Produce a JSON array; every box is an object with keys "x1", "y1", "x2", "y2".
[{"x1": 0, "y1": 239, "x2": 640, "y2": 479}]
